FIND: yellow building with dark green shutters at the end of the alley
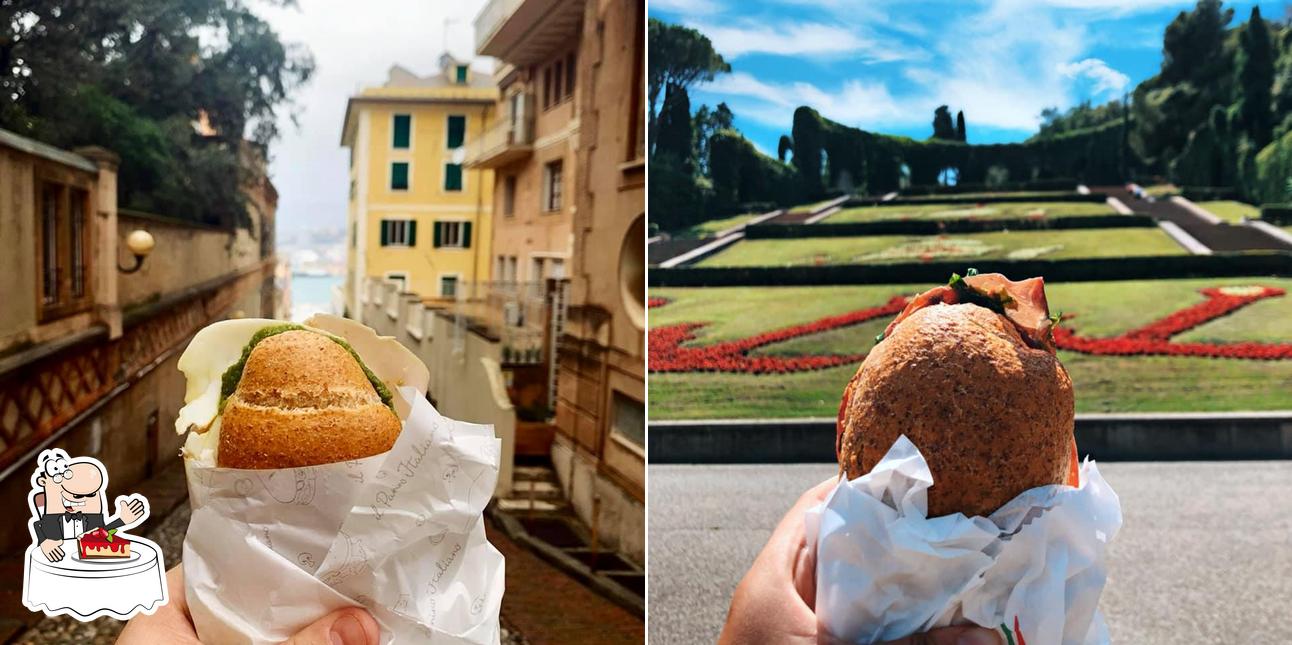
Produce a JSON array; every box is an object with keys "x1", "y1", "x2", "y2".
[{"x1": 341, "y1": 54, "x2": 497, "y2": 318}]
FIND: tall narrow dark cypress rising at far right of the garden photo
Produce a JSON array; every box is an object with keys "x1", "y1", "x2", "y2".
[{"x1": 1234, "y1": 6, "x2": 1275, "y2": 150}]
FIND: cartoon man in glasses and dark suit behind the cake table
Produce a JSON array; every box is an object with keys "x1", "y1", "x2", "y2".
[{"x1": 31, "y1": 449, "x2": 149, "y2": 562}]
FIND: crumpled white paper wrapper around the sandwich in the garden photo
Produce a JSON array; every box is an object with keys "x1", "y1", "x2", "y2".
[{"x1": 805, "y1": 436, "x2": 1121, "y2": 645}]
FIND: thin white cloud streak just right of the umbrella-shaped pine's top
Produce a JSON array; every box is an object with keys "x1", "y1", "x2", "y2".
[{"x1": 693, "y1": 22, "x2": 920, "y2": 62}]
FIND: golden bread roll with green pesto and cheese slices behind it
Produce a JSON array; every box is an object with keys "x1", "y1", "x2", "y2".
[{"x1": 218, "y1": 330, "x2": 401, "y2": 468}]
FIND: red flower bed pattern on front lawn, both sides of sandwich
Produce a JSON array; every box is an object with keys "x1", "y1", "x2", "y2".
[{"x1": 649, "y1": 287, "x2": 1292, "y2": 374}]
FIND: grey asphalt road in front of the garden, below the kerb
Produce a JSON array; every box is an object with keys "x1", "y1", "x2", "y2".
[{"x1": 649, "y1": 461, "x2": 1292, "y2": 645}]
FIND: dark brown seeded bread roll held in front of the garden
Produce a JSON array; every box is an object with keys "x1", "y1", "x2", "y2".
[{"x1": 837, "y1": 302, "x2": 1075, "y2": 517}]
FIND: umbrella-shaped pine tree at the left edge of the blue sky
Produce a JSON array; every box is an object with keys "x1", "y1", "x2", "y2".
[{"x1": 646, "y1": 18, "x2": 731, "y2": 151}]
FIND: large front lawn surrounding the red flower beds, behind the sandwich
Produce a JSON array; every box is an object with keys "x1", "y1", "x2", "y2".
[{"x1": 650, "y1": 278, "x2": 1292, "y2": 419}]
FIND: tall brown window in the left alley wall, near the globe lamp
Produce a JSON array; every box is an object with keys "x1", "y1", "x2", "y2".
[{"x1": 36, "y1": 181, "x2": 90, "y2": 319}]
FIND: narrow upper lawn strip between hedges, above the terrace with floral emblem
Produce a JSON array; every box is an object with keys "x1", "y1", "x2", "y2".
[{"x1": 824, "y1": 202, "x2": 1114, "y2": 224}]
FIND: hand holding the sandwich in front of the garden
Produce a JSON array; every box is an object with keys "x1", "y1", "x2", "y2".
[{"x1": 718, "y1": 477, "x2": 1000, "y2": 645}]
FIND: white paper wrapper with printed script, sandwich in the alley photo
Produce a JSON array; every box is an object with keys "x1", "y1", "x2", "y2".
[{"x1": 183, "y1": 388, "x2": 503, "y2": 644}]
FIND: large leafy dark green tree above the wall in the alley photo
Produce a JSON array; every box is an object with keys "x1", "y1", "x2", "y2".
[{"x1": 0, "y1": 0, "x2": 313, "y2": 225}]
